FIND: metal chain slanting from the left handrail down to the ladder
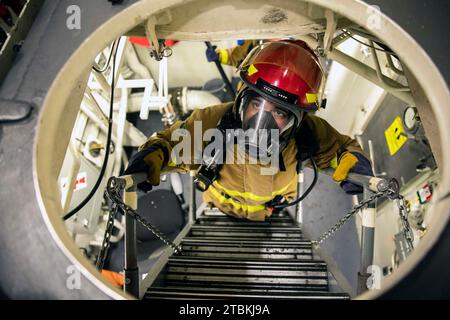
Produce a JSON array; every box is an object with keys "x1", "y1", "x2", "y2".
[{"x1": 106, "y1": 180, "x2": 182, "y2": 254}]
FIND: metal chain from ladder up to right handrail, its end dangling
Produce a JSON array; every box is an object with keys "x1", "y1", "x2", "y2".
[{"x1": 311, "y1": 188, "x2": 414, "y2": 252}]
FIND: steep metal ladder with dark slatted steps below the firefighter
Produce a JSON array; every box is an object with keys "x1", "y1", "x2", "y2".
[{"x1": 144, "y1": 209, "x2": 349, "y2": 300}]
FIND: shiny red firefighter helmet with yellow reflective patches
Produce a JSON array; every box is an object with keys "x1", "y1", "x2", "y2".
[{"x1": 239, "y1": 40, "x2": 323, "y2": 125}]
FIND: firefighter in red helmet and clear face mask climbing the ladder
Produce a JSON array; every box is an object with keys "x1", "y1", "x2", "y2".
[{"x1": 126, "y1": 41, "x2": 372, "y2": 221}]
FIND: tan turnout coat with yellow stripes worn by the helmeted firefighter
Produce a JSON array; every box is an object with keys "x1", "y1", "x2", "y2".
[{"x1": 140, "y1": 103, "x2": 363, "y2": 221}]
